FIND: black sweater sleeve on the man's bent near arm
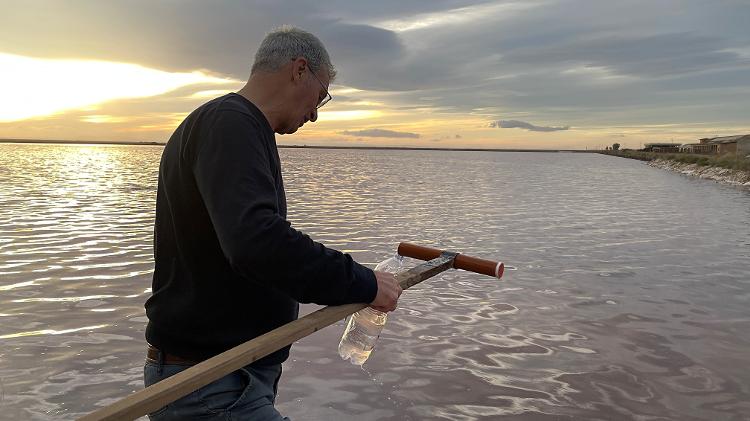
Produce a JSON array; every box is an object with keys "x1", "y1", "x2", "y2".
[{"x1": 193, "y1": 111, "x2": 377, "y2": 305}]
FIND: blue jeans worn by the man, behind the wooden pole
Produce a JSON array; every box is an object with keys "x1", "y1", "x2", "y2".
[{"x1": 143, "y1": 359, "x2": 289, "y2": 421}]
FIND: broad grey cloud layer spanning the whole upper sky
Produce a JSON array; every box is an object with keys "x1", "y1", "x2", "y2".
[{"x1": 0, "y1": 0, "x2": 750, "y2": 130}]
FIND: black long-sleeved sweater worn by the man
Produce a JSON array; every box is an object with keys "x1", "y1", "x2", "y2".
[{"x1": 146, "y1": 93, "x2": 377, "y2": 364}]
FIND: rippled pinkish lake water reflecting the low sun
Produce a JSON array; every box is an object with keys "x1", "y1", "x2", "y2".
[{"x1": 0, "y1": 144, "x2": 750, "y2": 421}]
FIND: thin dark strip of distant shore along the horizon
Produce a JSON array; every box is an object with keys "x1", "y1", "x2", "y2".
[{"x1": 0, "y1": 139, "x2": 599, "y2": 153}]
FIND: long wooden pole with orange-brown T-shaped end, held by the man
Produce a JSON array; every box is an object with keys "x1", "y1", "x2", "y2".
[{"x1": 80, "y1": 243, "x2": 503, "y2": 421}]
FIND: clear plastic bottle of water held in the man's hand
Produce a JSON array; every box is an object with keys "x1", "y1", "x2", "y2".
[{"x1": 339, "y1": 255, "x2": 403, "y2": 366}]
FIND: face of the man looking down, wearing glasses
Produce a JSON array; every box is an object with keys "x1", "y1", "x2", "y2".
[{"x1": 280, "y1": 67, "x2": 329, "y2": 134}]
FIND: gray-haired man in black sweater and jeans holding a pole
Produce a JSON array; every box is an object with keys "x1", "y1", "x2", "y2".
[{"x1": 144, "y1": 27, "x2": 401, "y2": 420}]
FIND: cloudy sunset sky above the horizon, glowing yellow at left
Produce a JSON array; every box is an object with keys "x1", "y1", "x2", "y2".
[{"x1": 0, "y1": 0, "x2": 750, "y2": 149}]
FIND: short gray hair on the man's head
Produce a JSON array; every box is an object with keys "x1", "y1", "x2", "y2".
[{"x1": 250, "y1": 25, "x2": 336, "y2": 81}]
